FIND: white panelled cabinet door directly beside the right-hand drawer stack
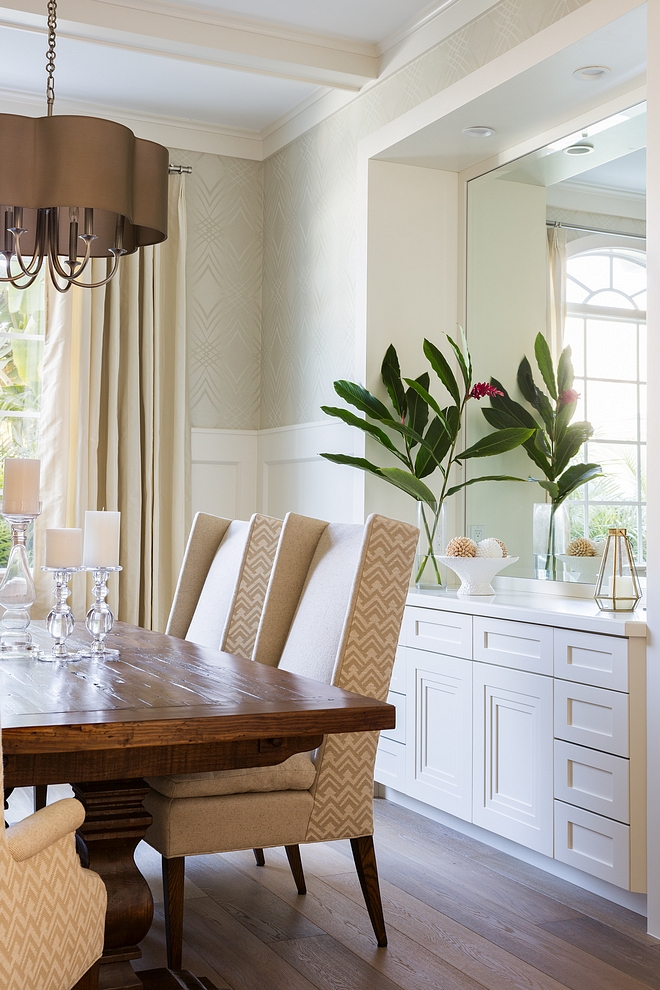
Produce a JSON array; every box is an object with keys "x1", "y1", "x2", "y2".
[{"x1": 472, "y1": 663, "x2": 553, "y2": 856}]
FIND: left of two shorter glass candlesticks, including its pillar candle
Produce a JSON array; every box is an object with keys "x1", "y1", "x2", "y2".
[{"x1": 39, "y1": 529, "x2": 83, "y2": 660}]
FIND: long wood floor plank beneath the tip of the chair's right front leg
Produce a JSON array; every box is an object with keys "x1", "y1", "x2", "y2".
[{"x1": 231, "y1": 853, "x2": 484, "y2": 990}]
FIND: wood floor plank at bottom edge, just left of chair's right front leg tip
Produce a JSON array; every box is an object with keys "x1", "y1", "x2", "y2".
[{"x1": 274, "y1": 935, "x2": 408, "y2": 990}]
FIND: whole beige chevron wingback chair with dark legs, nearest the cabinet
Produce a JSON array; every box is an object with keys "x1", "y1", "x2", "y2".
[{"x1": 145, "y1": 513, "x2": 418, "y2": 969}]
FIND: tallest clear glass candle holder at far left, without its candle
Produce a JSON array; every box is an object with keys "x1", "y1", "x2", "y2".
[{"x1": 0, "y1": 503, "x2": 41, "y2": 659}]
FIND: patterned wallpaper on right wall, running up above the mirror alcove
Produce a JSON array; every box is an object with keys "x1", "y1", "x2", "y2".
[{"x1": 261, "y1": 0, "x2": 588, "y2": 428}]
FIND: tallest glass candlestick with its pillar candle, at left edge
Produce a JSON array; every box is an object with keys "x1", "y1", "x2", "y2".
[{"x1": 0, "y1": 457, "x2": 41, "y2": 658}]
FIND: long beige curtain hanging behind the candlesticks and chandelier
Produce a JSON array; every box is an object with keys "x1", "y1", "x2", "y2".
[{"x1": 34, "y1": 176, "x2": 190, "y2": 630}]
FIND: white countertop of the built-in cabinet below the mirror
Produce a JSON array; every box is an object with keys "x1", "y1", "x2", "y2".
[{"x1": 407, "y1": 589, "x2": 646, "y2": 637}]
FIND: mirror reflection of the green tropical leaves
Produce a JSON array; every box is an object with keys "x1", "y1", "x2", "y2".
[{"x1": 481, "y1": 333, "x2": 603, "y2": 576}]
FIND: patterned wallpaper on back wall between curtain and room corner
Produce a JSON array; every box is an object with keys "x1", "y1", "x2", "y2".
[{"x1": 171, "y1": 149, "x2": 263, "y2": 430}]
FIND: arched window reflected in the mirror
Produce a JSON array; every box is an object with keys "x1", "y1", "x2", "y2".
[{"x1": 564, "y1": 238, "x2": 646, "y2": 564}]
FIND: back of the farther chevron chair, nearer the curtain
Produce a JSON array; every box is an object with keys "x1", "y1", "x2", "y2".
[{"x1": 166, "y1": 512, "x2": 282, "y2": 659}]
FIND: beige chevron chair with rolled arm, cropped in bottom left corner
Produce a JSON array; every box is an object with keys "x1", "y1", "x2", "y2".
[{"x1": 0, "y1": 720, "x2": 107, "y2": 990}]
